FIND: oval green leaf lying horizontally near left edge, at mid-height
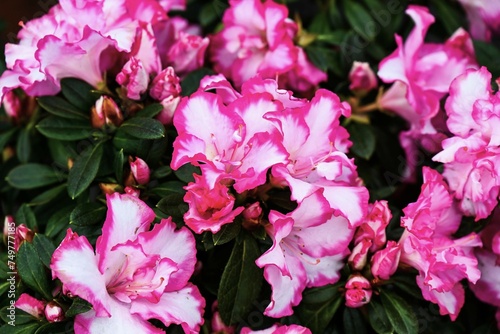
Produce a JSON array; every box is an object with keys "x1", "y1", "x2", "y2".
[{"x1": 5, "y1": 163, "x2": 60, "y2": 189}]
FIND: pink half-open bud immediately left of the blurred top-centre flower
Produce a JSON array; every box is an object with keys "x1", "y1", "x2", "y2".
[{"x1": 167, "y1": 31, "x2": 209, "y2": 74}]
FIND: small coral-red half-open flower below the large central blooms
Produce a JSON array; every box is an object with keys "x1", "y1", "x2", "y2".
[{"x1": 184, "y1": 174, "x2": 245, "y2": 233}]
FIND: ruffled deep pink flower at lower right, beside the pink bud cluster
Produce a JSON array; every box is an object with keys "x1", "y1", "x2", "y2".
[{"x1": 399, "y1": 167, "x2": 482, "y2": 320}]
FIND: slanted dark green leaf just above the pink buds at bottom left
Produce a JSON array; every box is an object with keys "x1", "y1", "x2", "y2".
[{"x1": 16, "y1": 242, "x2": 52, "y2": 300}]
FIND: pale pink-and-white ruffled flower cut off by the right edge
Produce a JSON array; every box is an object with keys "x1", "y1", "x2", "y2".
[{"x1": 433, "y1": 67, "x2": 500, "y2": 220}]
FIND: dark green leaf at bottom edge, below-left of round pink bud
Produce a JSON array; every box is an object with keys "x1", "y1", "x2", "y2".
[{"x1": 296, "y1": 283, "x2": 343, "y2": 333}]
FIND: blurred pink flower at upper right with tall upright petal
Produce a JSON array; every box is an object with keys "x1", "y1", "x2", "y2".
[{"x1": 378, "y1": 5, "x2": 477, "y2": 180}]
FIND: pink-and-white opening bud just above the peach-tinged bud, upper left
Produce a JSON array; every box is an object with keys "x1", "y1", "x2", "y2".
[{"x1": 116, "y1": 57, "x2": 149, "y2": 100}]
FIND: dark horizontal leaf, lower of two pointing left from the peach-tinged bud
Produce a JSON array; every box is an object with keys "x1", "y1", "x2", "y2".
[{"x1": 36, "y1": 116, "x2": 95, "y2": 140}]
